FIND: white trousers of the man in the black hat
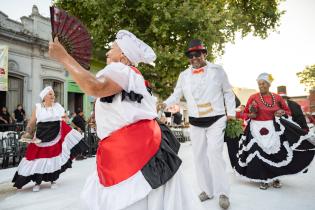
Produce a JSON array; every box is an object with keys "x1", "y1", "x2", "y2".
[{"x1": 190, "y1": 116, "x2": 229, "y2": 196}]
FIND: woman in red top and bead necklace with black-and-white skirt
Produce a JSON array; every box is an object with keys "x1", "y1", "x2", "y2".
[{"x1": 235, "y1": 73, "x2": 314, "y2": 189}]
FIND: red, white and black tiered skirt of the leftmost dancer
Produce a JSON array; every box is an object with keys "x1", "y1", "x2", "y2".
[{"x1": 12, "y1": 121, "x2": 88, "y2": 189}]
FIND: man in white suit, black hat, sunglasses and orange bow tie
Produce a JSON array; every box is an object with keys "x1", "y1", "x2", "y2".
[{"x1": 163, "y1": 39, "x2": 235, "y2": 209}]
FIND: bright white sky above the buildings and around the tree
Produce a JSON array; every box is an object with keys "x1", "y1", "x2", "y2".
[{"x1": 0, "y1": 0, "x2": 315, "y2": 96}]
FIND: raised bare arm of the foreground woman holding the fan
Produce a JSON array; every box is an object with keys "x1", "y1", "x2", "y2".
[{"x1": 49, "y1": 37, "x2": 122, "y2": 97}]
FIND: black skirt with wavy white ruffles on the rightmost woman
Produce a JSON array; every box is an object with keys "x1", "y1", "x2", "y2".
[{"x1": 233, "y1": 117, "x2": 315, "y2": 182}]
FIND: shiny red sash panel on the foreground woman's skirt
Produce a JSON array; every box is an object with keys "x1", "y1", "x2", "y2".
[{"x1": 96, "y1": 120, "x2": 161, "y2": 187}]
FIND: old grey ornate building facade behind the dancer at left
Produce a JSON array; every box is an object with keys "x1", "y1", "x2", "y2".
[{"x1": 0, "y1": 5, "x2": 92, "y2": 117}]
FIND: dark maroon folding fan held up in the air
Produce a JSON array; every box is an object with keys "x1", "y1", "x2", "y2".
[{"x1": 50, "y1": 7, "x2": 92, "y2": 70}]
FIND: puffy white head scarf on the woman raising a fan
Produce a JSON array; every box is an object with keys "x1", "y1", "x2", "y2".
[{"x1": 115, "y1": 30, "x2": 156, "y2": 66}]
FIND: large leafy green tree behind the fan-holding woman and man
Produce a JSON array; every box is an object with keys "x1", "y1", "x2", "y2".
[{"x1": 55, "y1": 0, "x2": 283, "y2": 98}]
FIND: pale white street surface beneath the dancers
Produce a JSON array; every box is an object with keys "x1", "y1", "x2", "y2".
[{"x1": 0, "y1": 143, "x2": 315, "y2": 210}]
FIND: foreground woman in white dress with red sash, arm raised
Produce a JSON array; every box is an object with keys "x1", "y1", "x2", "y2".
[{"x1": 49, "y1": 30, "x2": 200, "y2": 210}]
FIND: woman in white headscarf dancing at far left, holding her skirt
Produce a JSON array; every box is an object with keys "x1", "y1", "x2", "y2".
[{"x1": 12, "y1": 86, "x2": 87, "y2": 192}]
